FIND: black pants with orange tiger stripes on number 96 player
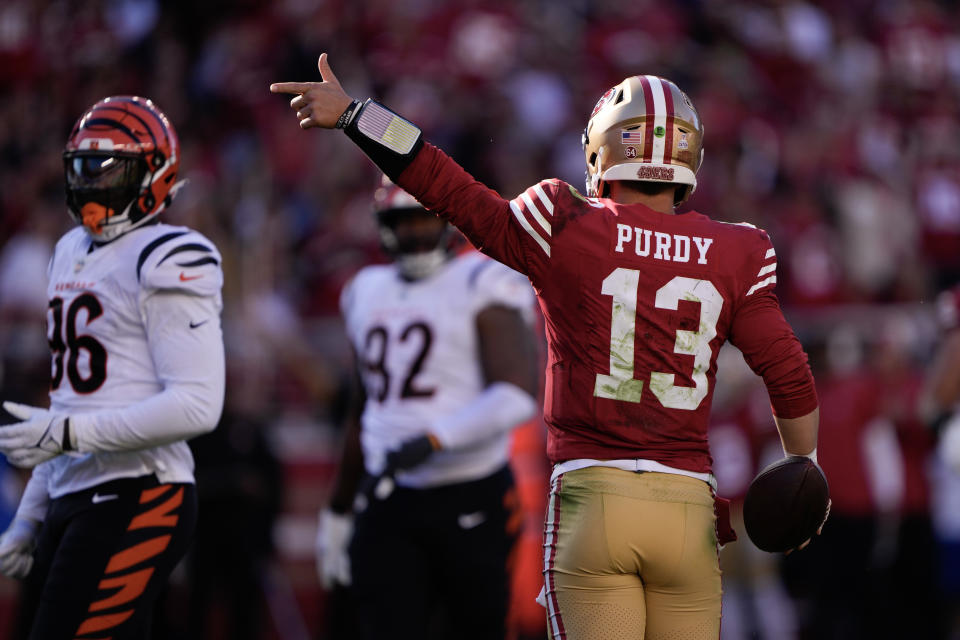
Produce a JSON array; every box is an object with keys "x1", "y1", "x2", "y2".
[{"x1": 20, "y1": 475, "x2": 197, "y2": 640}]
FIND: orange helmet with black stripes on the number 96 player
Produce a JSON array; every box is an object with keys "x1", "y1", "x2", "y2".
[{"x1": 63, "y1": 96, "x2": 180, "y2": 242}]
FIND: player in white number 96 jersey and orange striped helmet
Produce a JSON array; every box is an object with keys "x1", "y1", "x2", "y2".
[{"x1": 0, "y1": 96, "x2": 224, "y2": 640}]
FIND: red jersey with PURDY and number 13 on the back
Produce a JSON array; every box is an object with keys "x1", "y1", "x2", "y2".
[{"x1": 398, "y1": 144, "x2": 817, "y2": 472}]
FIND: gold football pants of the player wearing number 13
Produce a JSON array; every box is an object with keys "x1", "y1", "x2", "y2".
[{"x1": 544, "y1": 467, "x2": 721, "y2": 640}]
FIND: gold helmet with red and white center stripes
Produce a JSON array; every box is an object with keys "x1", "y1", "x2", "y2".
[{"x1": 583, "y1": 76, "x2": 703, "y2": 204}]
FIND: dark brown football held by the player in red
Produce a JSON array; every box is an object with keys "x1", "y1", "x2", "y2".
[{"x1": 743, "y1": 456, "x2": 830, "y2": 553}]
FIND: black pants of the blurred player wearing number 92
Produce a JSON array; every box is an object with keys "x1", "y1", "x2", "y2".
[{"x1": 350, "y1": 467, "x2": 522, "y2": 640}]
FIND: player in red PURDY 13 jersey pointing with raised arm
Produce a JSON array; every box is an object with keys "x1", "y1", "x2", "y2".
[{"x1": 271, "y1": 54, "x2": 819, "y2": 639}]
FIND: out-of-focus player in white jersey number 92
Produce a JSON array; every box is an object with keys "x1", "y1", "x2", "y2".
[{"x1": 318, "y1": 182, "x2": 537, "y2": 640}]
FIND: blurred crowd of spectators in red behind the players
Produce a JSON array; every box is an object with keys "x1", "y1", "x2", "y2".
[{"x1": 0, "y1": 0, "x2": 960, "y2": 640}]
